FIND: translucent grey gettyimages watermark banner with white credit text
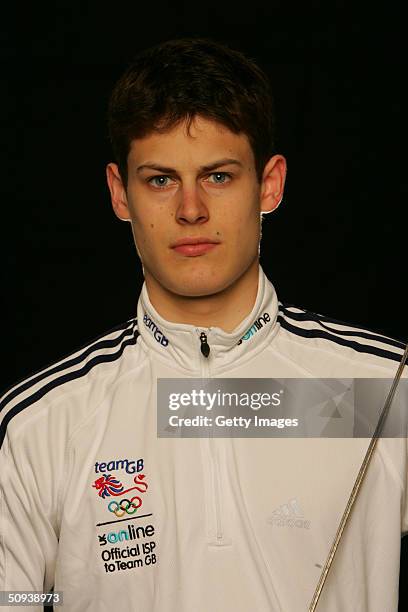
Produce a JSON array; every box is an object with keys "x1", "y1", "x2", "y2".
[{"x1": 157, "y1": 378, "x2": 408, "y2": 438}]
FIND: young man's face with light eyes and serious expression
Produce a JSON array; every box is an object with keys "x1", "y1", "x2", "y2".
[{"x1": 108, "y1": 117, "x2": 280, "y2": 296}]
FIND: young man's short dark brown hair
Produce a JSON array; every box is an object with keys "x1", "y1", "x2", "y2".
[{"x1": 108, "y1": 38, "x2": 275, "y2": 186}]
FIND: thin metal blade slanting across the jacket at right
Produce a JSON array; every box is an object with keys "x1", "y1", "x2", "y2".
[{"x1": 309, "y1": 344, "x2": 408, "y2": 612}]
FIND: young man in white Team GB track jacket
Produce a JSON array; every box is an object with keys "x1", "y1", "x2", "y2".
[{"x1": 0, "y1": 39, "x2": 408, "y2": 612}]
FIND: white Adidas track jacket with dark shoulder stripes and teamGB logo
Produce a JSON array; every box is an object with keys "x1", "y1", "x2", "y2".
[{"x1": 0, "y1": 267, "x2": 408, "y2": 612}]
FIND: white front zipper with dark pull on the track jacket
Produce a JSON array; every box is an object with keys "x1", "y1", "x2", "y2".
[{"x1": 197, "y1": 329, "x2": 230, "y2": 546}]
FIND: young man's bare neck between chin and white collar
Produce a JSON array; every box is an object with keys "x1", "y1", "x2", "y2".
[{"x1": 145, "y1": 259, "x2": 259, "y2": 332}]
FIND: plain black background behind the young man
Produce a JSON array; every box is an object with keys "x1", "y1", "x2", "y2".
[{"x1": 1, "y1": 1, "x2": 408, "y2": 610}]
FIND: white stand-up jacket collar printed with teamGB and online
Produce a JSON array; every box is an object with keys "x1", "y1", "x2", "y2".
[{"x1": 137, "y1": 266, "x2": 278, "y2": 376}]
